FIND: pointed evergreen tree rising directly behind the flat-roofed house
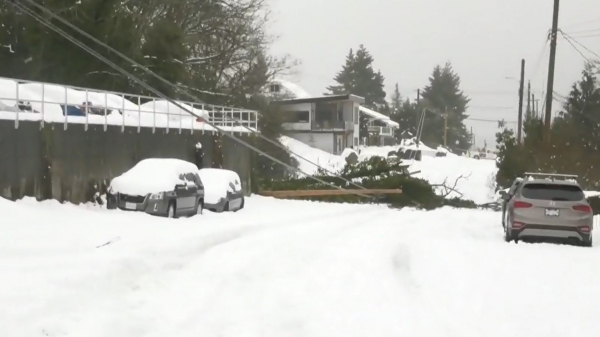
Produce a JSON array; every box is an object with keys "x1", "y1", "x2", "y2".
[{"x1": 327, "y1": 45, "x2": 389, "y2": 138}]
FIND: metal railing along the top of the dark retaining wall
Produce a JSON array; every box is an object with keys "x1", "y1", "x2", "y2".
[{"x1": 0, "y1": 77, "x2": 258, "y2": 133}]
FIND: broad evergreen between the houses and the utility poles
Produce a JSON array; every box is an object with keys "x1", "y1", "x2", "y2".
[{"x1": 422, "y1": 63, "x2": 471, "y2": 152}]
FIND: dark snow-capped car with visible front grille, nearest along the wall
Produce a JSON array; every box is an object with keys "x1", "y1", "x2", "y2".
[{"x1": 107, "y1": 158, "x2": 204, "y2": 218}]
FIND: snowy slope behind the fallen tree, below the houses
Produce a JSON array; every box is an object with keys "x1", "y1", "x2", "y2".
[{"x1": 281, "y1": 137, "x2": 497, "y2": 204}]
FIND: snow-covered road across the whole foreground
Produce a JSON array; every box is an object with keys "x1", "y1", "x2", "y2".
[{"x1": 0, "y1": 197, "x2": 600, "y2": 337}]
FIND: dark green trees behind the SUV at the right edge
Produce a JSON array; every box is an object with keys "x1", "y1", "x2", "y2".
[{"x1": 496, "y1": 65, "x2": 600, "y2": 189}]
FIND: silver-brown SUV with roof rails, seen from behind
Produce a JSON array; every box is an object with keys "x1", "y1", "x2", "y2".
[{"x1": 500, "y1": 173, "x2": 594, "y2": 247}]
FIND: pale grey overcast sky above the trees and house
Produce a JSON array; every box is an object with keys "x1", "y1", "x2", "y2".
[{"x1": 270, "y1": 0, "x2": 600, "y2": 145}]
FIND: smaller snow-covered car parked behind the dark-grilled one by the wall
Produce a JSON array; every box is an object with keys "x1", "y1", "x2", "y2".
[{"x1": 198, "y1": 168, "x2": 244, "y2": 212}]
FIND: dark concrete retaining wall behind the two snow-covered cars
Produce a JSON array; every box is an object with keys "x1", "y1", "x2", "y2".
[{"x1": 0, "y1": 120, "x2": 251, "y2": 203}]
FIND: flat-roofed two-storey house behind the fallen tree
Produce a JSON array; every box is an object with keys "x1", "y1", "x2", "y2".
[{"x1": 270, "y1": 95, "x2": 365, "y2": 154}]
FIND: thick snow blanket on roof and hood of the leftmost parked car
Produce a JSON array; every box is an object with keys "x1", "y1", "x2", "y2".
[{"x1": 110, "y1": 158, "x2": 198, "y2": 196}]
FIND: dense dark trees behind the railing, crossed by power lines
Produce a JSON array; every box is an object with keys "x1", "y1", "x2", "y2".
[{"x1": 0, "y1": 0, "x2": 290, "y2": 104}]
